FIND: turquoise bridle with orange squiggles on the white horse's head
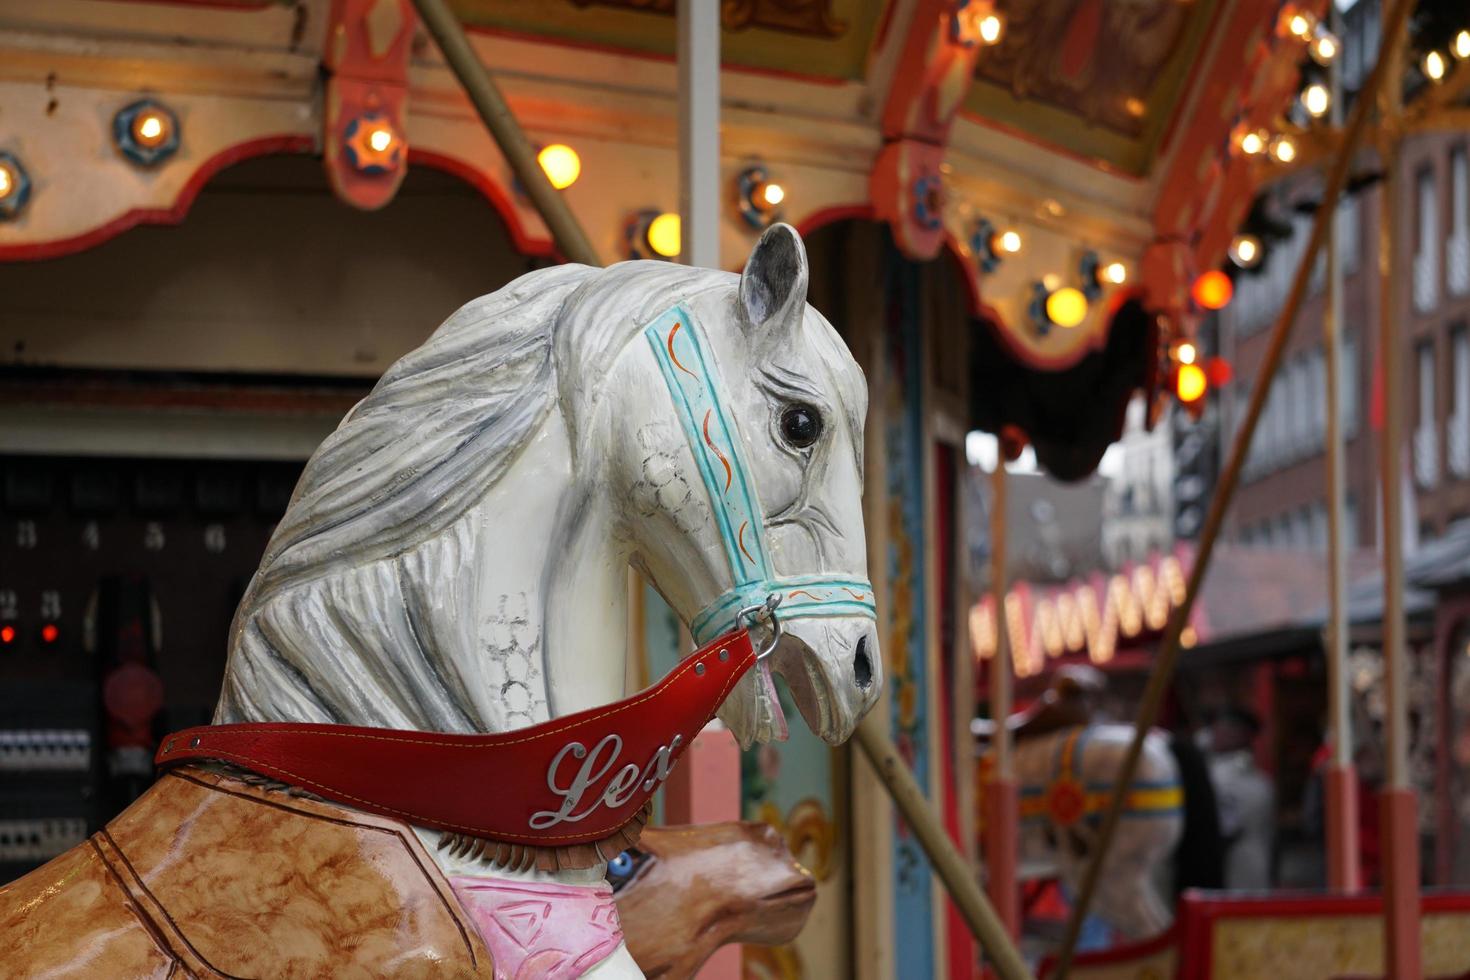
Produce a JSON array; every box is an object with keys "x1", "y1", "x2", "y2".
[{"x1": 644, "y1": 306, "x2": 878, "y2": 645}]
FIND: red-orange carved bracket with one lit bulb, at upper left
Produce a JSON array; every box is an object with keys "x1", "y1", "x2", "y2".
[{"x1": 322, "y1": 0, "x2": 415, "y2": 210}]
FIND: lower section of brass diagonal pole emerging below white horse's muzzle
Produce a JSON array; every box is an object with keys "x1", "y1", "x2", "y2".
[{"x1": 857, "y1": 711, "x2": 1032, "y2": 980}]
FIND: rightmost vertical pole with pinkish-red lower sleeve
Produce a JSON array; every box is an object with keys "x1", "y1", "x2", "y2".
[{"x1": 1377, "y1": 24, "x2": 1421, "y2": 980}]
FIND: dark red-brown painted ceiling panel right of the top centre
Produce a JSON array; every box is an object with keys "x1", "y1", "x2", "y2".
[{"x1": 964, "y1": 0, "x2": 1220, "y2": 175}]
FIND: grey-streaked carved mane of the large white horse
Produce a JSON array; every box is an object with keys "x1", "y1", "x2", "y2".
[{"x1": 215, "y1": 263, "x2": 734, "y2": 732}]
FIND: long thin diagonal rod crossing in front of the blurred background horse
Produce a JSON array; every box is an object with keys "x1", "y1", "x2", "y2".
[{"x1": 1054, "y1": 0, "x2": 1414, "y2": 980}]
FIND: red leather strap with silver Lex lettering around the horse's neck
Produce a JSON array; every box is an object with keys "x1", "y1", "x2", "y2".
[{"x1": 154, "y1": 630, "x2": 756, "y2": 846}]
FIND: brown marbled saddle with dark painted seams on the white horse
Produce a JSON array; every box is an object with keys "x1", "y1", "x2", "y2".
[{"x1": 0, "y1": 765, "x2": 495, "y2": 979}]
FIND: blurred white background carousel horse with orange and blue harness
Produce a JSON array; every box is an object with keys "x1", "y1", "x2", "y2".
[{"x1": 1014, "y1": 724, "x2": 1193, "y2": 939}]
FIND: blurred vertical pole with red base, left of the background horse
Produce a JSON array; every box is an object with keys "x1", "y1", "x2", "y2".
[{"x1": 985, "y1": 461, "x2": 1020, "y2": 936}]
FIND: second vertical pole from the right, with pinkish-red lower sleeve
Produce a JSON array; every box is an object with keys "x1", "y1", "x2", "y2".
[{"x1": 1322, "y1": 4, "x2": 1363, "y2": 892}]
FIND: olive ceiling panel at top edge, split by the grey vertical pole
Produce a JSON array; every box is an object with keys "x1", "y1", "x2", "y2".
[{"x1": 450, "y1": 0, "x2": 894, "y2": 79}]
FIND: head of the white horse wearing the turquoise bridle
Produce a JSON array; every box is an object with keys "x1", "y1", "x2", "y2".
[{"x1": 590, "y1": 225, "x2": 882, "y2": 746}]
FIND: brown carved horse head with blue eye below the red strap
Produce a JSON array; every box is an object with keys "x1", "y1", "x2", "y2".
[{"x1": 607, "y1": 823, "x2": 816, "y2": 980}]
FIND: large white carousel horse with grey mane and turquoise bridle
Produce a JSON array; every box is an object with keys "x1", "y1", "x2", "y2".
[{"x1": 204, "y1": 225, "x2": 882, "y2": 979}]
